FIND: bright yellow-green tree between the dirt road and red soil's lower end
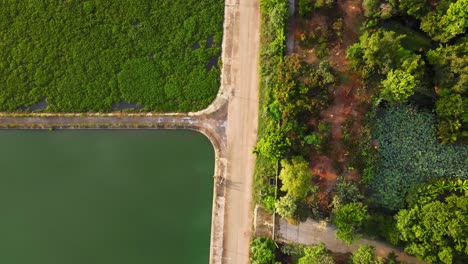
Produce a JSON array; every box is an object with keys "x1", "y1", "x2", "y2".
[{"x1": 279, "y1": 156, "x2": 312, "y2": 201}]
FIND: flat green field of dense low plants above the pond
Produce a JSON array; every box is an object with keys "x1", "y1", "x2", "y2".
[{"x1": 0, "y1": 0, "x2": 224, "y2": 112}]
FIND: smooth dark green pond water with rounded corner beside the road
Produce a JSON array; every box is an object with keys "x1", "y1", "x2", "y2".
[{"x1": 0, "y1": 130, "x2": 214, "y2": 264}]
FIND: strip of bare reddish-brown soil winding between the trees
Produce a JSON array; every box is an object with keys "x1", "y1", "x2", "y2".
[{"x1": 293, "y1": 0, "x2": 365, "y2": 210}]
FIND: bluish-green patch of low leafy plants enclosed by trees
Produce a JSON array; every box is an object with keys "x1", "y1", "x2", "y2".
[{"x1": 370, "y1": 106, "x2": 468, "y2": 210}]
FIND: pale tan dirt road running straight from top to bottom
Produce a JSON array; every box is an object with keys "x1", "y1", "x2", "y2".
[{"x1": 223, "y1": 0, "x2": 260, "y2": 264}]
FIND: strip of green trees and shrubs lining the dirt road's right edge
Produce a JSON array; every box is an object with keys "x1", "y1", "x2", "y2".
[{"x1": 255, "y1": 3, "x2": 335, "y2": 218}]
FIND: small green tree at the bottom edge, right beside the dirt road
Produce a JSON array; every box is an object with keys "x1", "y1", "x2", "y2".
[{"x1": 250, "y1": 237, "x2": 277, "y2": 264}]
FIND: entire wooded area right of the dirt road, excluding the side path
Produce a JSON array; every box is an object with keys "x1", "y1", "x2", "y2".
[{"x1": 251, "y1": 0, "x2": 468, "y2": 264}]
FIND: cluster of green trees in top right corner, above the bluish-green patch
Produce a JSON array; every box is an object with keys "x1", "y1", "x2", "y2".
[{"x1": 356, "y1": 0, "x2": 468, "y2": 144}]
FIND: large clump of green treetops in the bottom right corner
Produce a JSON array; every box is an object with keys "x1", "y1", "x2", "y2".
[{"x1": 395, "y1": 181, "x2": 468, "y2": 263}]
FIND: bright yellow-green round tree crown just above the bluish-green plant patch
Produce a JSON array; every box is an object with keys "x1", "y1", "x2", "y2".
[{"x1": 381, "y1": 69, "x2": 418, "y2": 103}]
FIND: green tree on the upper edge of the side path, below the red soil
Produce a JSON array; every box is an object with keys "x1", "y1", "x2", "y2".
[{"x1": 332, "y1": 203, "x2": 369, "y2": 244}]
